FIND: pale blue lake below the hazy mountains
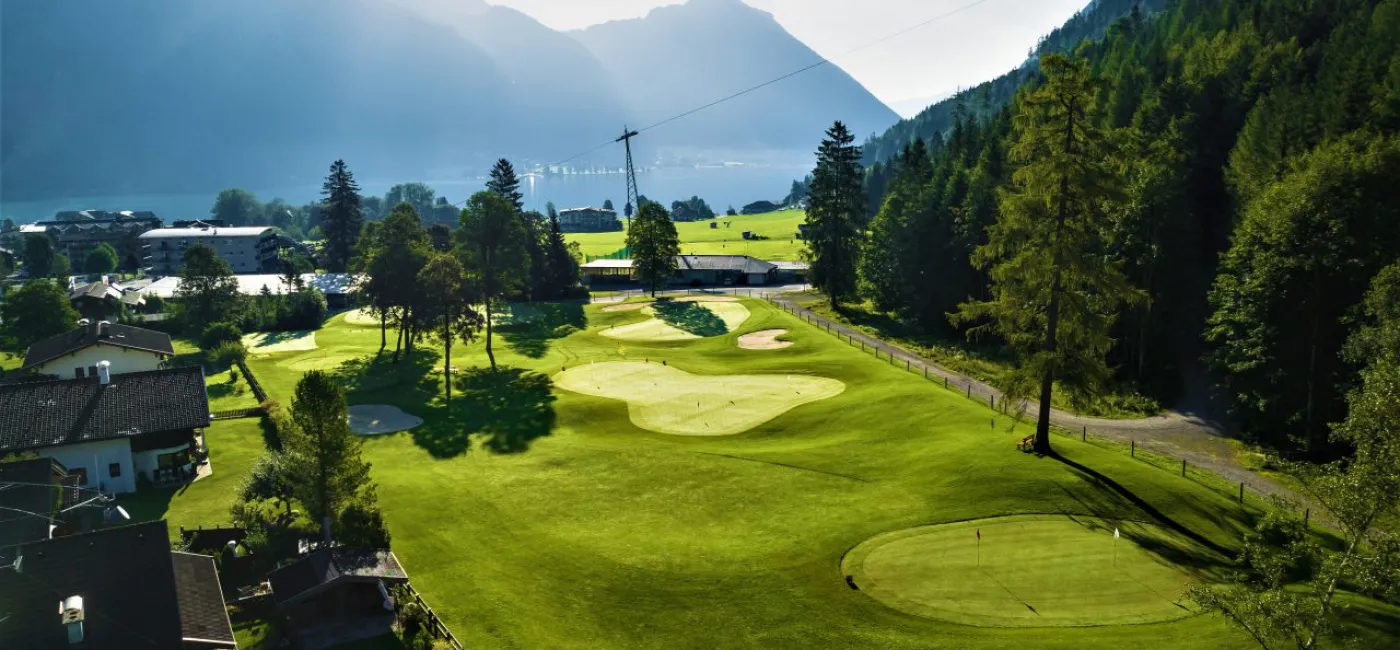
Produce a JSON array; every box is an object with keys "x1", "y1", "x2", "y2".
[{"x1": 0, "y1": 165, "x2": 811, "y2": 223}]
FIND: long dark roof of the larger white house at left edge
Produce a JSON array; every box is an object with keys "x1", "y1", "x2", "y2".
[{"x1": 0, "y1": 366, "x2": 209, "y2": 451}]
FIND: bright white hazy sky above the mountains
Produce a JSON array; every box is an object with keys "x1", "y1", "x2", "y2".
[{"x1": 489, "y1": 0, "x2": 1089, "y2": 115}]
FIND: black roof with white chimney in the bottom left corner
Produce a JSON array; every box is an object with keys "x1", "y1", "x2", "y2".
[{"x1": 0, "y1": 521, "x2": 182, "y2": 650}]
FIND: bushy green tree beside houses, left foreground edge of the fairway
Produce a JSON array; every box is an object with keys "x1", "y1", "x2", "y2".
[{"x1": 279, "y1": 370, "x2": 371, "y2": 544}]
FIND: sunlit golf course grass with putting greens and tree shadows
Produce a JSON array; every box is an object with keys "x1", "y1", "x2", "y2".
[{"x1": 141, "y1": 300, "x2": 1400, "y2": 650}]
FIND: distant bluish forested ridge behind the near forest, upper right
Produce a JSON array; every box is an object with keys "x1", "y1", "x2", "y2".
[{"x1": 861, "y1": 0, "x2": 1166, "y2": 175}]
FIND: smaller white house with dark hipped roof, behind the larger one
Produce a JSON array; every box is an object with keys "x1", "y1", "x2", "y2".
[{"x1": 24, "y1": 318, "x2": 175, "y2": 380}]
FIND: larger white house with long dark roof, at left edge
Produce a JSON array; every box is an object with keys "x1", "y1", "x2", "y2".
[{"x1": 0, "y1": 363, "x2": 210, "y2": 493}]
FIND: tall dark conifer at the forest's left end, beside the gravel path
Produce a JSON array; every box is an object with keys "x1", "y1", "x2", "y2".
[{"x1": 806, "y1": 122, "x2": 865, "y2": 308}]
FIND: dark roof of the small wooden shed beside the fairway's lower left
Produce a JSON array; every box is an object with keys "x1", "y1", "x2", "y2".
[{"x1": 267, "y1": 548, "x2": 409, "y2": 605}]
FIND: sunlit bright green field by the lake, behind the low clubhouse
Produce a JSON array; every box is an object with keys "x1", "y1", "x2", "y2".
[{"x1": 564, "y1": 210, "x2": 806, "y2": 262}]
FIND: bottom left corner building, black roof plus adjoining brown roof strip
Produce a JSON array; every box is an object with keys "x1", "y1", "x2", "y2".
[{"x1": 0, "y1": 521, "x2": 237, "y2": 650}]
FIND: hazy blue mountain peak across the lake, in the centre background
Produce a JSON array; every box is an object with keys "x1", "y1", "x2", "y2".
[{"x1": 570, "y1": 0, "x2": 899, "y2": 150}]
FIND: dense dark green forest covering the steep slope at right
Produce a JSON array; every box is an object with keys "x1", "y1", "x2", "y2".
[{"x1": 861, "y1": 0, "x2": 1400, "y2": 455}]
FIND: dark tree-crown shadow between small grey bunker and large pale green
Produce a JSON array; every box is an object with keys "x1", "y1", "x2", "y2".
[{"x1": 413, "y1": 368, "x2": 556, "y2": 458}]
